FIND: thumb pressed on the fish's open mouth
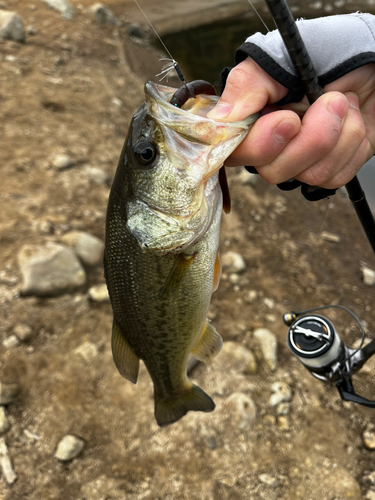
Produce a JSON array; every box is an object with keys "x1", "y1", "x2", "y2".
[{"x1": 207, "y1": 57, "x2": 288, "y2": 122}]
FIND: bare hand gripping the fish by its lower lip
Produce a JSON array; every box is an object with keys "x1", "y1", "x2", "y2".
[{"x1": 208, "y1": 58, "x2": 375, "y2": 189}]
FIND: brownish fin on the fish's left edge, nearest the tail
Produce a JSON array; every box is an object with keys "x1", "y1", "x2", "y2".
[{"x1": 112, "y1": 321, "x2": 139, "y2": 384}]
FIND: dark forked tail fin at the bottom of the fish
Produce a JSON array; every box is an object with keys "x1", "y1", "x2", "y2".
[{"x1": 155, "y1": 384, "x2": 215, "y2": 427}]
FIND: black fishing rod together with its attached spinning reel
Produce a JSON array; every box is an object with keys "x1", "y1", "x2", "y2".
[{"x1": 265, "y1": 0, "x2": 375, "y2": 408}]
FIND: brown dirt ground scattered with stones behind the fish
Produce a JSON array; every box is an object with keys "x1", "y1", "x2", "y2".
[{"x1": 0, "y1": 0, "x2": 375, "y2": 500}]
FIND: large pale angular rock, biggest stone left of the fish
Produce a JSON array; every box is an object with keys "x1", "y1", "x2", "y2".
[{"x1": 18, "y1": 242, "x2": 86, "y2": 297}]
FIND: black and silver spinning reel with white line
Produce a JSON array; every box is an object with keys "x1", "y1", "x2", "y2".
[{"x1": 283, "y1": 305, "x2": 375, "y2": 408}]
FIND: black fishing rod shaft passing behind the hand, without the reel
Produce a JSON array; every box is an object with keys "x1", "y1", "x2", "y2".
[{"x1": 265, "y1": 0, "x2": 375, "y2": 253}]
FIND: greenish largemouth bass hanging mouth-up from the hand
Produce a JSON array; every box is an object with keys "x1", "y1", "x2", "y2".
[{"x1": 104, "y1": 82, "x2": 257, "y2": 427}]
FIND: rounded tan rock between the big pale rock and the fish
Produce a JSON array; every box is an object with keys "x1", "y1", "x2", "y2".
[{"x1": 62, "y1": 231, "x2": 104, "y2": 266}]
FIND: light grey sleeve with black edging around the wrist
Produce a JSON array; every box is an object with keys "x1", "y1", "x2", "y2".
[{"x1": 235, "y1": 12, "x2": 375, "y2": 104}]
